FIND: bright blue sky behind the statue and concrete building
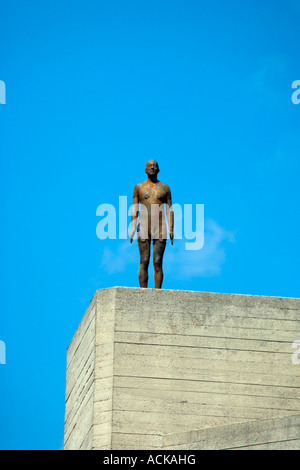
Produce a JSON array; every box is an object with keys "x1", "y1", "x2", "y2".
[{"x1": 0, "y1": 0, "x2": 300, "y2": 449}]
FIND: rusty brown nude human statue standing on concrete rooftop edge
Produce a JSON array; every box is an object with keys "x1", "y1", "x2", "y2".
[{"x1": 130, "y1": 160, "x2": 174, "y2": 289}]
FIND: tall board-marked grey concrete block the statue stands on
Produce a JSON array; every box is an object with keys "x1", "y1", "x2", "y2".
[{"x1": 65, "y1": 287, "x2": 300, "y2": 449}]
